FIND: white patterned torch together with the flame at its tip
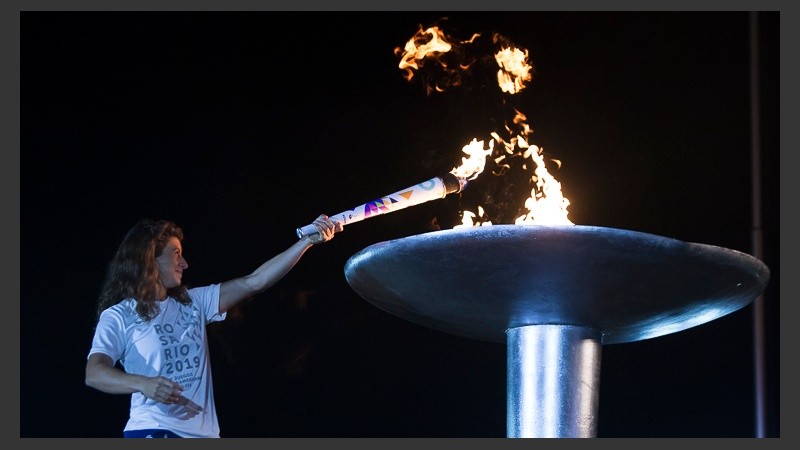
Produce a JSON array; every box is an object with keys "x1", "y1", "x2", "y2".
[{"x1": 297, "y1": 139, "x2": 494, "y2": 238}]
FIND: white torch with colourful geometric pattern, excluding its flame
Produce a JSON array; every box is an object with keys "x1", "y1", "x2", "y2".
[{"x1": 297, "y1": 173, "x2": 467, "y2": 238}]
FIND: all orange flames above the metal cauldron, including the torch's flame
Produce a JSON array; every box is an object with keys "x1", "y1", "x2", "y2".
[{"x1": 395, "y1": 26, "x2": 573, "y2": 228}]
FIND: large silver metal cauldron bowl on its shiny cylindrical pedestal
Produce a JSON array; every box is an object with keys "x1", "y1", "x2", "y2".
[{"x1": 344, "y1": 225, "x2": 769, "y2": 438}]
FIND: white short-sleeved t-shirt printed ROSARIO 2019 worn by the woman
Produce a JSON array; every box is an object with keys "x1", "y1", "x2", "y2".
[{"x1": 87, "y1": 284, "x2": 227, "y2": 438}]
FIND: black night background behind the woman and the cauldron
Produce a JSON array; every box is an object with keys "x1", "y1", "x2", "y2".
[{"x1": 19, "y1": 11, "x2": 780, "y2": 437}]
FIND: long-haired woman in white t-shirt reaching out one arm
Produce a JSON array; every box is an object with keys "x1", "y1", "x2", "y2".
[{"x1": 86, "y1": 214, "x2": 342, "y2": 438}]
